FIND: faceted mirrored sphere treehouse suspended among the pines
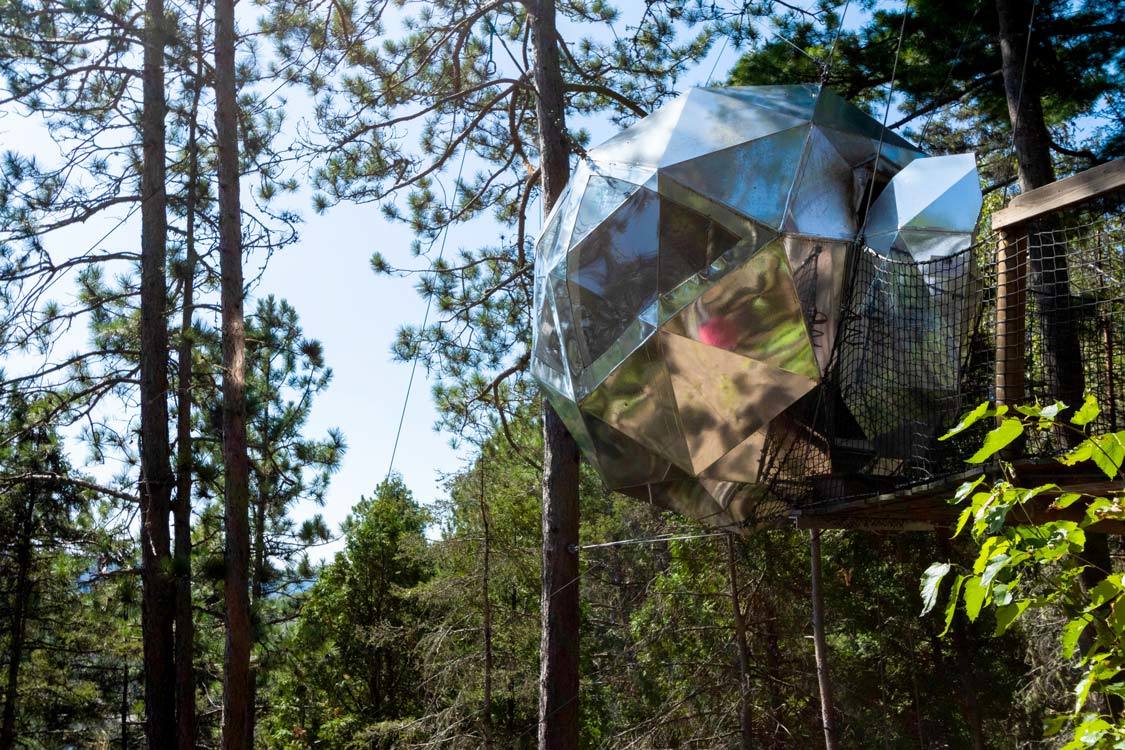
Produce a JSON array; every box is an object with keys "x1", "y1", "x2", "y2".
[{"x1": 531, "y1": 85, "x2": 980, "y2": 525}]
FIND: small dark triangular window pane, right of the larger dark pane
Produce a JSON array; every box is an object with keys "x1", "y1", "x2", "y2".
[{"x1": 658, "y1": 197, "x2": 739, "y2": 293}]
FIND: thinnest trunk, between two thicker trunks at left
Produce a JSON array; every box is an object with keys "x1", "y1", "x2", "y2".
[{"x1": 172, "y1": 8, "x2": 204, "y2": 750}]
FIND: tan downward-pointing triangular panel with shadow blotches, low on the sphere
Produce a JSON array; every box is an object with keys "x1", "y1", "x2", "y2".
[{"x1": 660, "y1": 332, "x2": 817, "y2": 473}]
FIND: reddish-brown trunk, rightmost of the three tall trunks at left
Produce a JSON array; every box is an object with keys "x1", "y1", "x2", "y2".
[{"x1": 215, "y1": 0, "x2": 252, "y2": 750}]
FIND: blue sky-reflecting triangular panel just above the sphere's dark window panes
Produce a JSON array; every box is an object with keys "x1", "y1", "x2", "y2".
[{"x1": 660, "y1": 125, "x2": 811, "y2": 229}]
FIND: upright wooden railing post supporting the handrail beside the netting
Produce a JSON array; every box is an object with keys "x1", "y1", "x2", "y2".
[{"x1": 996, "y1": 225, "x2": 1027, "y2": 406}]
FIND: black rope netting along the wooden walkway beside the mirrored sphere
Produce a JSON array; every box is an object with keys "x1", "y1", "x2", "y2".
[{"x1": 764, "y1": 191, "x2": 1125, "y2": 507}]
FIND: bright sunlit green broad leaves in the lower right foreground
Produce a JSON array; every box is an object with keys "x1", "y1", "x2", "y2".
[{"x1": 921, "y1": 397, "x2": 1125, "y2": 749}]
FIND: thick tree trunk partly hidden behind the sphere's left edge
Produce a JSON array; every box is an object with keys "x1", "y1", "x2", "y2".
[{"x1": 528, "y1": 0, "x2": 578, "y2": 750}]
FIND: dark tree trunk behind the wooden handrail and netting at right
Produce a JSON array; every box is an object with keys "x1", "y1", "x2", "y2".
[{"x1": 996, "y1": 0, "x2": 1086, "y2": 416}]
